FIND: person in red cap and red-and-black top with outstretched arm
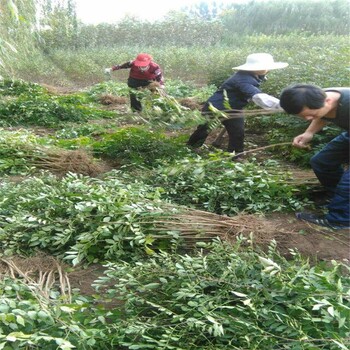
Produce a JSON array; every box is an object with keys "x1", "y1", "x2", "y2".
[{"x1": 105, "y1": 53, "x2": 164, "y2": 111}]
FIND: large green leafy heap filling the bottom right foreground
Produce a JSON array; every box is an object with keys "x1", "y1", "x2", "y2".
[{"x1": 96, "y1": 241, "x2": 350, "y2": 350}]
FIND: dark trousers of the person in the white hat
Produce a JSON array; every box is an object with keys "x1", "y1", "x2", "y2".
[{"x1": 187, "y1": 117, "x2": 244, "y2": 153}]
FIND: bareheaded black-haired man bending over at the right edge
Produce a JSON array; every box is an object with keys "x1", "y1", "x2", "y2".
[{"x1": 280, "y1": 84, "x2": 350, "y2": 229}]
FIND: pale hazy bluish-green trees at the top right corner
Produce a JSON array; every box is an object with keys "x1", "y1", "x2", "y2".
[{"x1": 221, "y1": 0, "x2": 349, "y2": 35}]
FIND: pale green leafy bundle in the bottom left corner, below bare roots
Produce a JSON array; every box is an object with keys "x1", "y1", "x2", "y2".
[{"x1": 0, "y1": 277, "x2": 106, "y2": 350}]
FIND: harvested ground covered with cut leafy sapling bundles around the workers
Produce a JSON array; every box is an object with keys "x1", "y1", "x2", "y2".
[{"x1": 0, "y1": 77, "x2": 349, "y2": 349}]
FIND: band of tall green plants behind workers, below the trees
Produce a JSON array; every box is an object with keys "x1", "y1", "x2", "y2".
[{"x1": 10, "y1": 34, "x2": 350, "y2": 94}]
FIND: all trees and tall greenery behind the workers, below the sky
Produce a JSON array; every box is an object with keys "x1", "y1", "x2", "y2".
[{"x1": 0, "y1": 0, "x2": 349, "y2": 87}]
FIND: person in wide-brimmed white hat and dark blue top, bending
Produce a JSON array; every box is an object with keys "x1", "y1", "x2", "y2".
[{"x1": 187, "y1": 53, "x2": 288, "y2": 154}]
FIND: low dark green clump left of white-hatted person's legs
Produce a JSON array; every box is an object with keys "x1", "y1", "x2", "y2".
[{"x1": 92, "y1": 127, "x2": 190, "y2": 166}]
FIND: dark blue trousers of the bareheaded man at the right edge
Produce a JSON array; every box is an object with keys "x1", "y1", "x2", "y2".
[{"x1": 311, "y1": 132, "x2": 350, "y2": 226}]
